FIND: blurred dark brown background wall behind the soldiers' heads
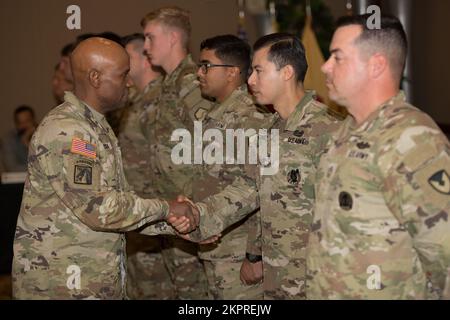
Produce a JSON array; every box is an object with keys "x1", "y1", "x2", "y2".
[{"x1": 0, "y1": 0, "x2": 450, "y2": 135}]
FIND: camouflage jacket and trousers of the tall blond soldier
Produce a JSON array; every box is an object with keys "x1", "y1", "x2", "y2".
[{"x1": 141, "y1": 55, "x2": 212, "y2": 299}]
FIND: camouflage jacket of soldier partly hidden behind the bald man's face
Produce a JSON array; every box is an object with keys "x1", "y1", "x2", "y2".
[{"x1": 118, "y1": 77, "x2": 162, "y2": 198}]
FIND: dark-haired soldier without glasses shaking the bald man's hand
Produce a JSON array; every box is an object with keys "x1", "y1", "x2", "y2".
[{"x1": 170, "y1": 34, "x2": 338, "y2": 299}]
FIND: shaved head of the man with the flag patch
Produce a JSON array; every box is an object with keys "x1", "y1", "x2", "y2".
[{"x1": 70, "y1": 37, "x2": 129, "y2": 113}]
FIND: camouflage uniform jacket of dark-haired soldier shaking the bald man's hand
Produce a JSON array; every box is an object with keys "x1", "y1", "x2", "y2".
[{"x1": 192, "y1": 92, "x2": 339, "y2": 299}]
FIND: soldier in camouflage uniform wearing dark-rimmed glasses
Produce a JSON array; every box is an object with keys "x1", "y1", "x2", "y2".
[{"x1": 193, "y1": 35, "x2": 267, "y2": 300}]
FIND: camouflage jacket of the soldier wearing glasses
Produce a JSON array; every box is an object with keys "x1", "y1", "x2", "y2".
[{"x1": 193, "y1": 85, "x2": 272, "y2": 262}]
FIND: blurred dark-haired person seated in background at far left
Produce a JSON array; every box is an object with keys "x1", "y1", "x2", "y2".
[{"x1": 1, "y1": 105, "x2": 37, "y2": 172}]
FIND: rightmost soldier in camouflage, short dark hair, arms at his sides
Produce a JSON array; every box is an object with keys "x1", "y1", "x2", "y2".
[{"x1": 307, "y1": 15, "x2": 450, "y2": 299}]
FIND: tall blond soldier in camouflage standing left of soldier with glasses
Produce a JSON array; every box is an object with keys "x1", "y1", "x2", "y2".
[{"x1": 141, "y1": 7, "x2": 212, "y2": 299}]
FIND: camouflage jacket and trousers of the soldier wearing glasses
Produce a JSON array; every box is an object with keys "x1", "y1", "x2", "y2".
[{"x1": 193, "y1": 85, "x2": 271, "y2": 300}]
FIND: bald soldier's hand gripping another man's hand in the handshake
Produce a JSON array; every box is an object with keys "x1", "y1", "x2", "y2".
[{"x1": 166, "y1": 201, "x2": 199, "y2": 233}]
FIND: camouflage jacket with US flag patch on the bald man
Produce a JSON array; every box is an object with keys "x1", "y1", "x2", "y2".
[{"x1": 12, "y1": 93, "x2": 168, "y2": 299}]
